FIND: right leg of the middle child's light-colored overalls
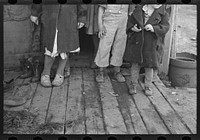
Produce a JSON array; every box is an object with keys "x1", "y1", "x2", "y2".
[{"x1": 110, "y1": 14, "x2": 128, "y2": 66}]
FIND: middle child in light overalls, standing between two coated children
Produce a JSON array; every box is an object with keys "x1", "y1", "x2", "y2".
[{"x1": 95, "y1": 4, "x2": 134, "y2": 82}]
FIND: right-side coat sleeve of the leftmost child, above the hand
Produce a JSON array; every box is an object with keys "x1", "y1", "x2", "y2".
[{"x1": 77, "y1": 4, "x2": 87, "y2": 24}]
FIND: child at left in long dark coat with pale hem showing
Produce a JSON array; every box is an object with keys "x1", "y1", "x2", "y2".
[{"x1": 31, "y1": 5, "x2": 87, "y2": 87}]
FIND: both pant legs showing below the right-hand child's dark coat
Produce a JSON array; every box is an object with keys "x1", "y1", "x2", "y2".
[{"x1": 131, "y1": 63, "x2": 153, "y2": 87}]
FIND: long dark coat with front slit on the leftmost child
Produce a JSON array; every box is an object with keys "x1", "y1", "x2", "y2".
[{"x1": 32, "y1": 5, "x2": 87, "y2": 53}]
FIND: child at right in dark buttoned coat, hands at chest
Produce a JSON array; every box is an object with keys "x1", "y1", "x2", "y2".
[{"x1": 124, "y1": 5, "x2": 169, "y2": 96}]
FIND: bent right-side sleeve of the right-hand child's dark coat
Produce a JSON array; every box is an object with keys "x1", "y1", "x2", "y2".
[{"x1": 153, "y1": 12, "x2": 170, "y2": 37}]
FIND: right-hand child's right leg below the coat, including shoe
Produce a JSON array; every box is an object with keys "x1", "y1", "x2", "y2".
[{"x1": 145, "y1": 68, "x2": 153, "y2": 96}]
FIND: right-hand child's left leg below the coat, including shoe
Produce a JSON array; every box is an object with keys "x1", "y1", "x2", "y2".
[{"x1": 128, "y1": 63, "x2": 140, "y2": 94}]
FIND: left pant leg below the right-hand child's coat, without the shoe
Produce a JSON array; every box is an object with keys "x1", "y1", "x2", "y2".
[{"x1": 131, "y1": 63, "x2": 140, "y2": 85}]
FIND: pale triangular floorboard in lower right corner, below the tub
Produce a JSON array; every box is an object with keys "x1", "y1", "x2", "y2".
[{"x1": 154, "y1": 81, "x2": 197, "y2": 134}]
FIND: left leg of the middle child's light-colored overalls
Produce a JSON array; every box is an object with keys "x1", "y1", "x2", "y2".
[{"x1": 94, "y1": 17, "x2": 117, "y2": 67}]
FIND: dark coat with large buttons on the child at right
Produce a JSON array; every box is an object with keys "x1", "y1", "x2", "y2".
[{"x1": 124, "y1": 5, "x2": 169, "y2": 68}]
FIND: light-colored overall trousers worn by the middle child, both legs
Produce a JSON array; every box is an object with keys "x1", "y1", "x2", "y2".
[{"x1": 94, "y1": 13, "x2": 128, "y2": 67}]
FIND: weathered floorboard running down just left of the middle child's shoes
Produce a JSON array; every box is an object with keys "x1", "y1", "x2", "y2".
[{"x1": 83, "y1": 69, "x2": 105, "y2": 134}]
